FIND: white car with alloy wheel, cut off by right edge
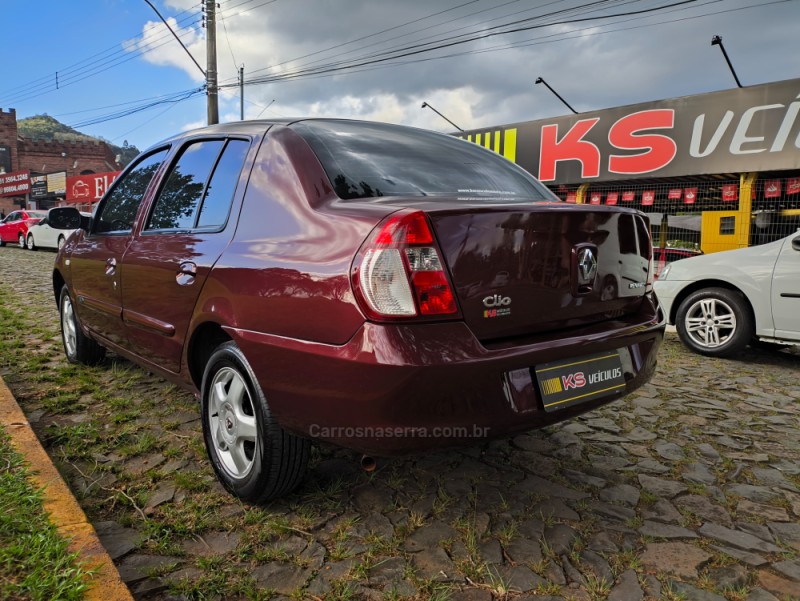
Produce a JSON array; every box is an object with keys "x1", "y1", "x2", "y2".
[{"x1": 654, "y1": 232, "x2": 800, "y2": 357}]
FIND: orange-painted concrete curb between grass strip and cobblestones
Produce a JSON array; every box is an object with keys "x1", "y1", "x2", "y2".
[{"x1": 0, "y1": 377, "x2": 133, "y2": 601}]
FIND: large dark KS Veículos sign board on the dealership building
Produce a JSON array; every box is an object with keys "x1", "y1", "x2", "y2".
[{"x1": 459, "y1": 79, "x2": 800, "y2": 184}]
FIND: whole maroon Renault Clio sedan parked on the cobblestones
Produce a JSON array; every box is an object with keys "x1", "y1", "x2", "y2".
[{"x1": 49, "y1": 119, "x2": 664, "y2": 502}]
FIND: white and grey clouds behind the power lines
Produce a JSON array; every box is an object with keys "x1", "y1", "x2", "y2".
[{"x1": 120, "y1": 0, "x2": 800, "y2": 138}]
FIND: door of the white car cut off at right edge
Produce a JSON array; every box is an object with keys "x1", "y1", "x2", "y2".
[{"x1": 771, "y1": 234, "x2": 800, "y2": 340}]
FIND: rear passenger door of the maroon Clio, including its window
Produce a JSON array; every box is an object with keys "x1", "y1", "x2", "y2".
[{"x1": 122, "y1": 139, "x2": 250, "y2": 373}]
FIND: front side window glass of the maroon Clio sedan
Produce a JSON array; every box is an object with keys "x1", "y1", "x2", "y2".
[{"x1": 93, "y1": 148, "x2": 168, "y2": 234}]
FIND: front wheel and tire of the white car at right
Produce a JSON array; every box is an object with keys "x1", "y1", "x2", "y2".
[{"x1": 675, "y1": 288, "x2": 755, "y2": 357}]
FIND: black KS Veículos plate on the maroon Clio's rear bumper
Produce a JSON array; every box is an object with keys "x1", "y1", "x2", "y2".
[{"x1": 534, "y1": 350, "x2": 625, "y2": 413}]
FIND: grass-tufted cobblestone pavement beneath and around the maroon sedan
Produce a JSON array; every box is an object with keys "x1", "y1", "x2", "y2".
[{"x1": 0, "y1": 248, "x2": 800, "y2": 601}]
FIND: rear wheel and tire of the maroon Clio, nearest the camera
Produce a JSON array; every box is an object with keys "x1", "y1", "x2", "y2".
[{"x1": 201, "y1": 342, "x2": 311, "y2": 504}]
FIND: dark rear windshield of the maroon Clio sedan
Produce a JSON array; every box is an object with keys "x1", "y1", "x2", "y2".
[{"x1": 291, "y1": 120, "x2": 559, "y2": 204}]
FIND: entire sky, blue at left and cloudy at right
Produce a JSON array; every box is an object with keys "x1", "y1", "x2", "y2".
[{"x1": 0, "y1": 0, "x2": 800, "y2": 150}]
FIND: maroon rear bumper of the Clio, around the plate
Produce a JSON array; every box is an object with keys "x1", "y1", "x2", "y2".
[{"x1": 230, "y1": 295, "x2": 665, "y2": 455}]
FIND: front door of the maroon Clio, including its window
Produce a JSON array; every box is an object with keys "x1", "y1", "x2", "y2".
[{"x1": 69, "y1": 148, "x2": 168, "y2": 346}]
